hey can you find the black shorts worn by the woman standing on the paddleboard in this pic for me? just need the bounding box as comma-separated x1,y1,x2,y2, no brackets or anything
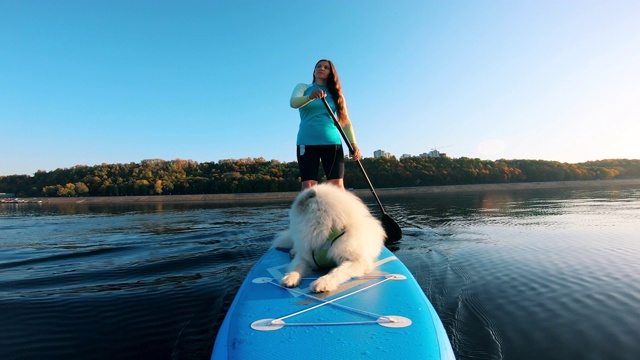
296,145,344,181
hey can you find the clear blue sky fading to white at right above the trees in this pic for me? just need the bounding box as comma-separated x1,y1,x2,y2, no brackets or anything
0,0,640,175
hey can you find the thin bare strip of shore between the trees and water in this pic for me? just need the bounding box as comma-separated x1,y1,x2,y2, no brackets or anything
7,179,640,204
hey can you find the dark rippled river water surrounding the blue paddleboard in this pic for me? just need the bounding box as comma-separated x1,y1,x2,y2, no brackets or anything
0,187,640,360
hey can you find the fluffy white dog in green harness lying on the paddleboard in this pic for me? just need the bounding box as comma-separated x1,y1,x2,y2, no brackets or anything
274,184,386,292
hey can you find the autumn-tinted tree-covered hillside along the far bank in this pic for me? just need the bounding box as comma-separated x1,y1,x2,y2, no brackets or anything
0,157,640,197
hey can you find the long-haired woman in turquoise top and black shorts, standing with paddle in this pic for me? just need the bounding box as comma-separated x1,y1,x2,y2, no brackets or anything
290,59,362,190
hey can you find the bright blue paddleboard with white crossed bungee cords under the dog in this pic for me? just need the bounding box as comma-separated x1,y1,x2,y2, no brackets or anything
211,248,455,360
